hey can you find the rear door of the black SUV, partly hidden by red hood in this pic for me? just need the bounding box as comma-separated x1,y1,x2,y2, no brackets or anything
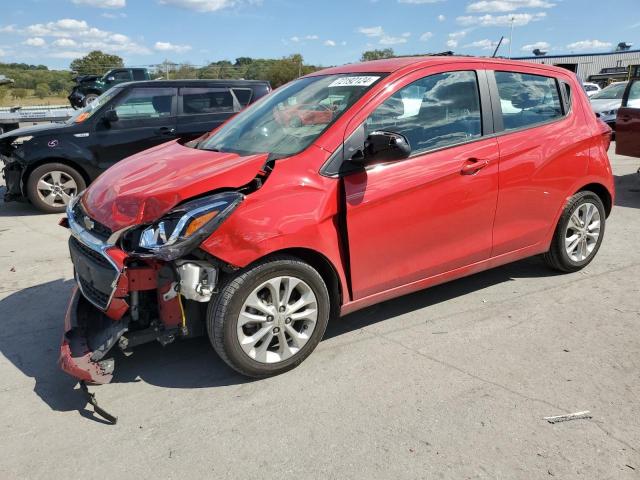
177,87,241,139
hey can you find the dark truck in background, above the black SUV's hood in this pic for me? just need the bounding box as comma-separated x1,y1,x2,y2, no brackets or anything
68,68,151,108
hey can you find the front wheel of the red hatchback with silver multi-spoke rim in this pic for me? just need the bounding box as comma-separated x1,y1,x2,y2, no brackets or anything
207,257,331,378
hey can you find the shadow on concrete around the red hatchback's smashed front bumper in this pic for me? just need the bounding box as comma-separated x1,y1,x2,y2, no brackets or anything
0,280,250,422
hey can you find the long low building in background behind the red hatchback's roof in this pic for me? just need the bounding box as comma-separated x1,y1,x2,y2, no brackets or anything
514,50,640,87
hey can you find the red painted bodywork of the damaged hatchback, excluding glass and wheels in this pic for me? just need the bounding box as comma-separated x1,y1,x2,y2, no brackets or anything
61,57,614,378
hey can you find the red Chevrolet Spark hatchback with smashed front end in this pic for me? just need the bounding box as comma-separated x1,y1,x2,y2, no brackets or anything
60,57,614,383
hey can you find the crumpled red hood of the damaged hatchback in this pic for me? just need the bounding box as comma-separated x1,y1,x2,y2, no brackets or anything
82,141,268,231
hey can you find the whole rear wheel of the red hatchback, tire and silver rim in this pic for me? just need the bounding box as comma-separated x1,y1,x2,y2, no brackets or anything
544,191,606,272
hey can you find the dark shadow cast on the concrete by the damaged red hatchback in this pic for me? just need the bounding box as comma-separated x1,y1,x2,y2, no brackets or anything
0,258,554,422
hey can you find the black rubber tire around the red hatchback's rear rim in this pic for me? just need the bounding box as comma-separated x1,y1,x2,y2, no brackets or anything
543,191,606,272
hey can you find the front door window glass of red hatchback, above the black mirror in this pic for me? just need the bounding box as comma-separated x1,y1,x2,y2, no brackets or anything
365,71,482,154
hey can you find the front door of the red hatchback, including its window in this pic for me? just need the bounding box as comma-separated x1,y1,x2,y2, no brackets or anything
344,70,499,299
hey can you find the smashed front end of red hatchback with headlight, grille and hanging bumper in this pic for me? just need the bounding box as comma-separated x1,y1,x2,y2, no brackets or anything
59,192,238,384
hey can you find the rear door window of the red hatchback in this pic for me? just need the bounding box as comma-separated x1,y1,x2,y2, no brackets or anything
495,72,563,130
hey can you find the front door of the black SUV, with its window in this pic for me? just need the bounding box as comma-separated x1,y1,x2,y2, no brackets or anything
94,87,177,169
